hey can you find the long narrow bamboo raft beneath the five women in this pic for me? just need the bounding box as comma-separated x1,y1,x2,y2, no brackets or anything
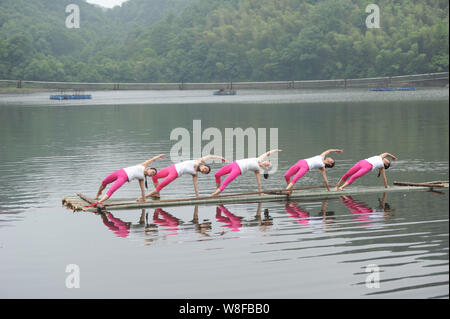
62,181,448,212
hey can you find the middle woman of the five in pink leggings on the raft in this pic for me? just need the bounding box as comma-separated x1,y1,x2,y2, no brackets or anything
211,150,281,196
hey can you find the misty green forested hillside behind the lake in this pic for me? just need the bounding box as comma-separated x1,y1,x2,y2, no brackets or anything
0,0,449,82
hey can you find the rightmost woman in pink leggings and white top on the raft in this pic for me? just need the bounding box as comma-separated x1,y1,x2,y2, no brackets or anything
336,153,397,190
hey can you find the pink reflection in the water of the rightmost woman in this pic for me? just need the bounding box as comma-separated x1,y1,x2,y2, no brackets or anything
340,193,394,221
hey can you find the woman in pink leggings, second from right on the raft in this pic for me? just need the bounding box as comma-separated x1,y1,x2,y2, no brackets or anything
284,149,343,193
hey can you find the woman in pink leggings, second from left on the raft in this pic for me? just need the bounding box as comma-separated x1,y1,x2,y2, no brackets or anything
145,155,226,198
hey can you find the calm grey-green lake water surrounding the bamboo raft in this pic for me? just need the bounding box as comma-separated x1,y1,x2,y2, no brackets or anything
0,89,449,299
